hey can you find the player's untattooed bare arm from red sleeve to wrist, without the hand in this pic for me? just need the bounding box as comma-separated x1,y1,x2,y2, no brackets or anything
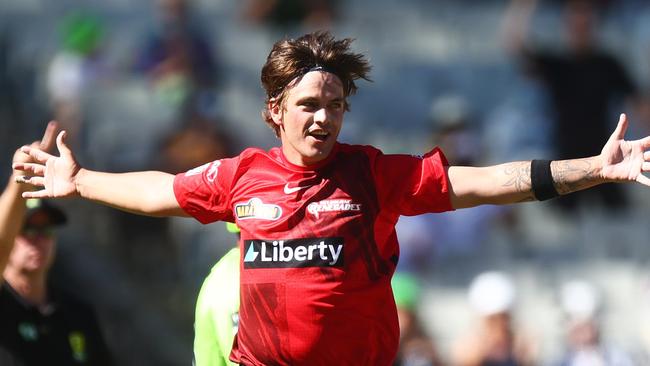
75,169,185,216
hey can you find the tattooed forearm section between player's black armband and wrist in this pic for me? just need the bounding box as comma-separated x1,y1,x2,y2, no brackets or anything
551,158,597,194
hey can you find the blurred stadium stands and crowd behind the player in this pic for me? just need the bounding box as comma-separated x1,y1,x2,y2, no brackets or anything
0,0,650,365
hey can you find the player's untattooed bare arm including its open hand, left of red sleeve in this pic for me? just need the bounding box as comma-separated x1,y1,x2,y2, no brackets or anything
13,127,187,216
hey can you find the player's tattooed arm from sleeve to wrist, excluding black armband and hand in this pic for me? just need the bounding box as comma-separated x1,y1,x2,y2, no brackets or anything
448,157,605,208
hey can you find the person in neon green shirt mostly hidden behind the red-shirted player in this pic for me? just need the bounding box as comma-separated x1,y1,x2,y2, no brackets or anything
194,223,239,366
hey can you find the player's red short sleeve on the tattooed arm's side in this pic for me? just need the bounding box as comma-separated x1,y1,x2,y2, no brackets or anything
374,148,453,216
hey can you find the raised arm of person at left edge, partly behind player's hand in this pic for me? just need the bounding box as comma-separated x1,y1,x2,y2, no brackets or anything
0,122,57,283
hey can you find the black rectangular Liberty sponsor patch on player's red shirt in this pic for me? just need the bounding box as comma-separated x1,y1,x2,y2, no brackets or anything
244,238,344,268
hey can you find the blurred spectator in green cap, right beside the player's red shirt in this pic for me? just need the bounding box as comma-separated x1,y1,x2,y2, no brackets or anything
391,272,442,366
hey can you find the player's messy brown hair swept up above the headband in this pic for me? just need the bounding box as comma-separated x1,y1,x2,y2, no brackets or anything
261,31,371,137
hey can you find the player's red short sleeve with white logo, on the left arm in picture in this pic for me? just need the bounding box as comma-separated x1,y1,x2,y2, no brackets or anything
174,158,239,224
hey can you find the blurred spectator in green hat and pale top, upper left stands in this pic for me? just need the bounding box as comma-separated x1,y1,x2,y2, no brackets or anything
47,12,106,149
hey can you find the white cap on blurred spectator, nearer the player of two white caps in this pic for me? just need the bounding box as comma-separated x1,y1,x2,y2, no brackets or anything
468,271,515,316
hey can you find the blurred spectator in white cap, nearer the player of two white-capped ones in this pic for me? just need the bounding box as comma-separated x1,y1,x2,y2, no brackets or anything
452,272,537,366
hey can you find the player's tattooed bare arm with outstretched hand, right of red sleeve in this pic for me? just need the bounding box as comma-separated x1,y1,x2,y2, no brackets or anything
448,114,650,208
